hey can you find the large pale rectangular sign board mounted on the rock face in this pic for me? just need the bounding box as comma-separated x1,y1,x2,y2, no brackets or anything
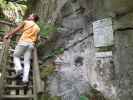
93,18,113,47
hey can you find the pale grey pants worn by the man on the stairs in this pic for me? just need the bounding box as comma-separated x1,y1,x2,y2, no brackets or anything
13,43,34,82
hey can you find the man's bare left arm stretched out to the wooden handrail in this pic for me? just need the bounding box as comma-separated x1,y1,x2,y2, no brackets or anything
4,23,24,39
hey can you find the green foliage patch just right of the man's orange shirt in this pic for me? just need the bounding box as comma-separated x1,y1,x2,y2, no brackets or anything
38,22,57,37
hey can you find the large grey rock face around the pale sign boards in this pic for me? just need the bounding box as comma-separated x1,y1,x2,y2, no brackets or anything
31,0,133,100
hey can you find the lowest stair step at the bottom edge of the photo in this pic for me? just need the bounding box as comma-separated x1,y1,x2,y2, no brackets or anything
2,95,34,100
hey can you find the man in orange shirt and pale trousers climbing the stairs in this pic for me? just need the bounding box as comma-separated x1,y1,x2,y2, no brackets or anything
4,14,40,84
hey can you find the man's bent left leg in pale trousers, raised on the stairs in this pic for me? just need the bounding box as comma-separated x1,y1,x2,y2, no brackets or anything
13,45,26,73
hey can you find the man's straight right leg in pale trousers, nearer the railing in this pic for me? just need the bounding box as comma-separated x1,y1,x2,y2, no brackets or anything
22,47,33,83
